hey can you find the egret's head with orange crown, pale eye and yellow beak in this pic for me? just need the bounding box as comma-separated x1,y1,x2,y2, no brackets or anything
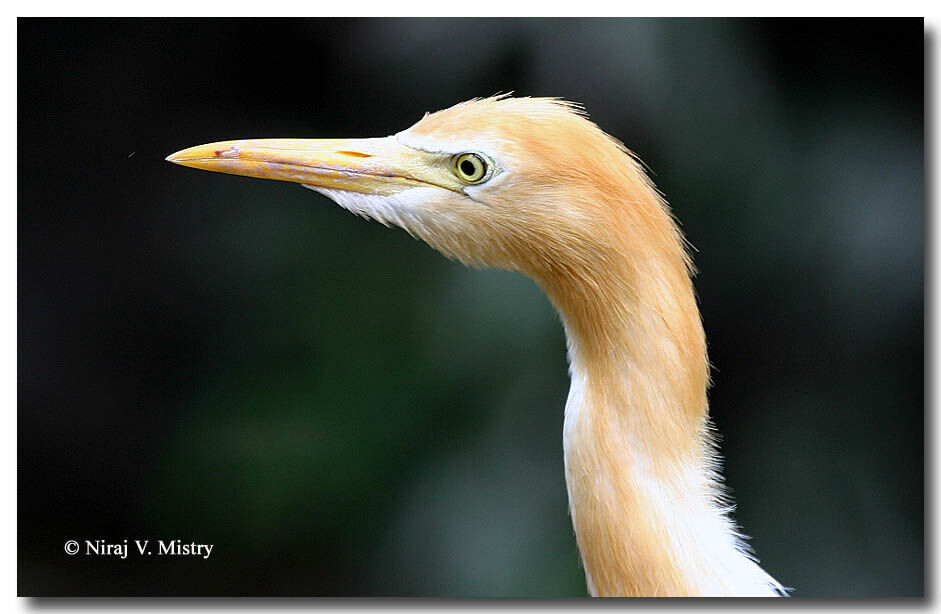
167,96,661,288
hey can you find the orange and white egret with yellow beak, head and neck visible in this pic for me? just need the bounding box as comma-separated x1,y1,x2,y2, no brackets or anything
167,96,785,597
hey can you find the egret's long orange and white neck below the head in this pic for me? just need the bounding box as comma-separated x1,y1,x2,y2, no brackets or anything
539,194,776,596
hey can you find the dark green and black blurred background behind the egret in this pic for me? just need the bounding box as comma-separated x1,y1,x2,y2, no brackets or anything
18,19,925,596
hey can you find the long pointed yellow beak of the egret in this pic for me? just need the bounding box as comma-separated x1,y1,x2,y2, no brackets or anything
167,137,453,196
